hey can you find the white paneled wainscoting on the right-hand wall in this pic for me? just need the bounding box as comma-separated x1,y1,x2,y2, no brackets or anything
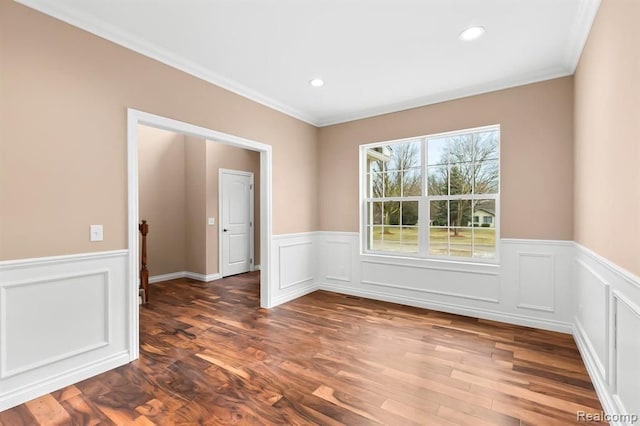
574,244,640,424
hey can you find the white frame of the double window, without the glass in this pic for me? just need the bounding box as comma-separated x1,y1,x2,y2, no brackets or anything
359,124,502,264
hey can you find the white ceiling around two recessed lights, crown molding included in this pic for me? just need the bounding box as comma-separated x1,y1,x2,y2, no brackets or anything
18,0,600,126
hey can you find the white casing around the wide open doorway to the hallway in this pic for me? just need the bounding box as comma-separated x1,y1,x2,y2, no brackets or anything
126,108,273,361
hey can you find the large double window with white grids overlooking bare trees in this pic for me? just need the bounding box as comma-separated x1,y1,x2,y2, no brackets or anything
361,126,500,260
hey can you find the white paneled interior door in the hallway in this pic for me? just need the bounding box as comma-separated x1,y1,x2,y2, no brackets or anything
219,170,253,277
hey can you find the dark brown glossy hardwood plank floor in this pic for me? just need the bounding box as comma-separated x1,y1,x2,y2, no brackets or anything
0,273,602,426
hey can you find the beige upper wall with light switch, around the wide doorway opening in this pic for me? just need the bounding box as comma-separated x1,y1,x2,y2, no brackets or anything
0,1,318,260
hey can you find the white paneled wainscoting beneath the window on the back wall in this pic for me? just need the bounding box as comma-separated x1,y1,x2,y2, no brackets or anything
315,232,574,333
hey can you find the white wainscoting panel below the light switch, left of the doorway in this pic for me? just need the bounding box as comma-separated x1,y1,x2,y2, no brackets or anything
0,250,129,411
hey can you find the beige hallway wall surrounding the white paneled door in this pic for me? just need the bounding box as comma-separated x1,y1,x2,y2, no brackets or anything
207,141,260,274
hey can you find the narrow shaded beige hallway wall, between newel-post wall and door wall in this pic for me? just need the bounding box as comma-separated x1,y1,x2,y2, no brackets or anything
184,136,210,274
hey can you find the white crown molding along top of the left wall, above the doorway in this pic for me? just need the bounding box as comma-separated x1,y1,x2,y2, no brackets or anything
15,0,318,126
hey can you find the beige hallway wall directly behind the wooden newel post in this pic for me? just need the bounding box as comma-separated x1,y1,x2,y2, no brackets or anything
138,126,187,275
